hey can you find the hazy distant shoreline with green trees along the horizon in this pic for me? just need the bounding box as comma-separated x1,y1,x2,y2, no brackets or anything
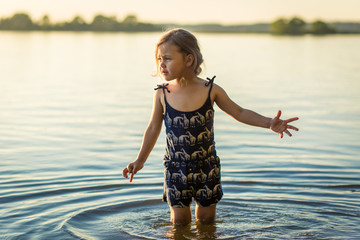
0,13,354,35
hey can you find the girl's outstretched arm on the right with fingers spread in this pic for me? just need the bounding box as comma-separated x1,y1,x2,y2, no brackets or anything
213,84,299,138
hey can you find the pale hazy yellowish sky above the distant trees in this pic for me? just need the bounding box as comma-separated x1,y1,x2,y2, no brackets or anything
0,0,360,24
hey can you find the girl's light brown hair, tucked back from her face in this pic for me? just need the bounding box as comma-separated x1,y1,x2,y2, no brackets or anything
155,28,204,76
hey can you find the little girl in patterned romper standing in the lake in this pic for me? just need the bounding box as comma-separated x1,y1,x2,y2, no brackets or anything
123,29,298,224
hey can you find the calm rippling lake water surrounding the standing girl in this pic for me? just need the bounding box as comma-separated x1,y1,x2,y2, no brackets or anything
0,32,360,239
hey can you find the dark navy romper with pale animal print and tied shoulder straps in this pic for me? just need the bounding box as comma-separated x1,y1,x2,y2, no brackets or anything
156,77,223,207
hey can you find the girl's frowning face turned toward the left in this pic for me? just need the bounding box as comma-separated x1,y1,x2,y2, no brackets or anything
157,43,188,81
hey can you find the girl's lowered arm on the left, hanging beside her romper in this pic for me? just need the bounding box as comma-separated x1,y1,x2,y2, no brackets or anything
123,90,163,178
